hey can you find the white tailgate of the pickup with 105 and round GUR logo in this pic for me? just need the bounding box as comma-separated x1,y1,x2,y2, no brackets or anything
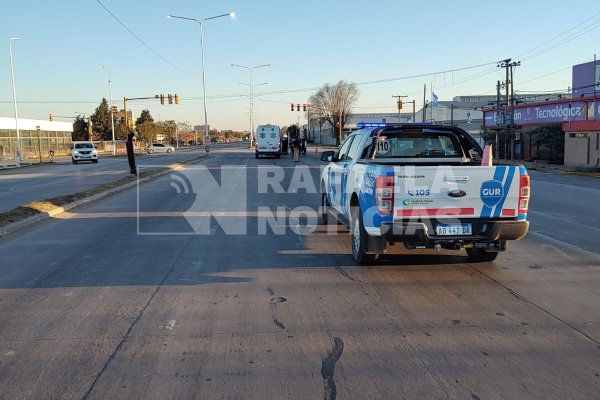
393,166,525,220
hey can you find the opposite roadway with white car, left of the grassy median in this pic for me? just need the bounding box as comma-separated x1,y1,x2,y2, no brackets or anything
0,148,214,212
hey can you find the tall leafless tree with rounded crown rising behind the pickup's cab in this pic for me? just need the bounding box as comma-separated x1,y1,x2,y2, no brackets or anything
309,80,358,144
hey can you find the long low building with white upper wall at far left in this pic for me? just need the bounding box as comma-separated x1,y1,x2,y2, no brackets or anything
0,117,73,158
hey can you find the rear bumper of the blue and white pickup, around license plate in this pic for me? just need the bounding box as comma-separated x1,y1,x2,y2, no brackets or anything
380,220,529,243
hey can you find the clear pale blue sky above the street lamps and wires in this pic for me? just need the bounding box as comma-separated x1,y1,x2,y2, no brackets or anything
0,0,600,130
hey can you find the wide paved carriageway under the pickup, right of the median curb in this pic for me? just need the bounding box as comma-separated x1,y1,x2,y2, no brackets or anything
0,148,600,399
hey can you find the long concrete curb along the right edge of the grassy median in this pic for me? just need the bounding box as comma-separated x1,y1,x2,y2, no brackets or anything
0,155,211,239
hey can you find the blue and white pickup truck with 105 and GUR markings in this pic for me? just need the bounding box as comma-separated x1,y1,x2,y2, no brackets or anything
321,124,530,264
